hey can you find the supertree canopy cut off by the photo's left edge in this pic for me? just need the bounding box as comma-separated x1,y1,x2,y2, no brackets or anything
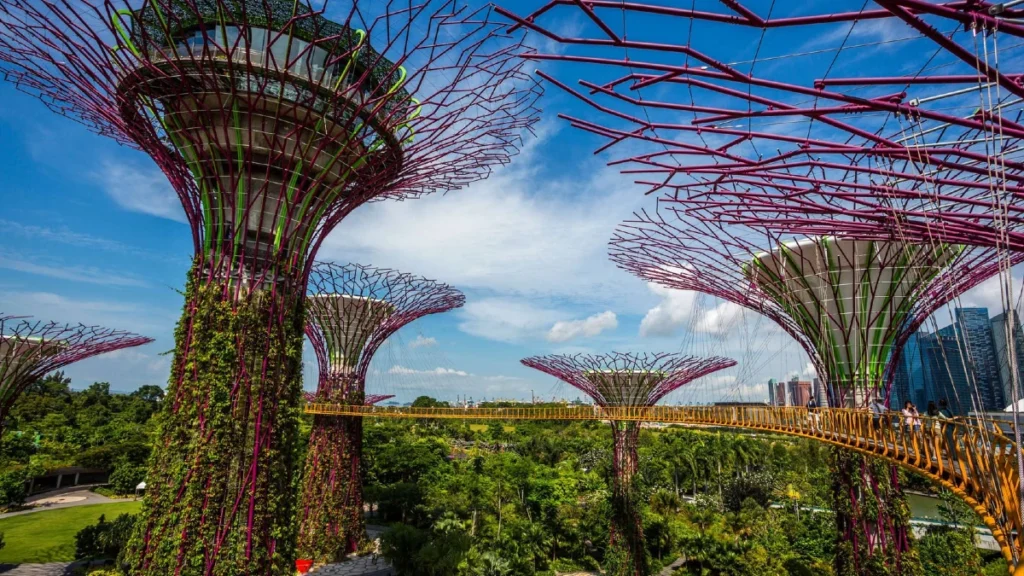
0,314,153,436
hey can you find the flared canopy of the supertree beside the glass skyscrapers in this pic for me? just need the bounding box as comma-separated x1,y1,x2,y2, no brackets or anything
609,200,1024,406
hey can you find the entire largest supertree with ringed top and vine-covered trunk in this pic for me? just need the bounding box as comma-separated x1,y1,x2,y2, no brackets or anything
0,0,540,575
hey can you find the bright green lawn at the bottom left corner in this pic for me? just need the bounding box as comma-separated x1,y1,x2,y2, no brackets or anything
0,501,142,564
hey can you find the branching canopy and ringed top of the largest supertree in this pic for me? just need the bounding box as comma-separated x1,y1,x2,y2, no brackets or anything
0,0,541,286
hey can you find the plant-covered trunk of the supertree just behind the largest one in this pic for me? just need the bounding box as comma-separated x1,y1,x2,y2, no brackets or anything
298,385,366,564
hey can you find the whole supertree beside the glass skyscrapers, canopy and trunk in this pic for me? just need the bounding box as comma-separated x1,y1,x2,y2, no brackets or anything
610,202,1024,574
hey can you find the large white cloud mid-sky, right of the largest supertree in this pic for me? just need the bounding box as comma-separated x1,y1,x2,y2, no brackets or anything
317,126,647,305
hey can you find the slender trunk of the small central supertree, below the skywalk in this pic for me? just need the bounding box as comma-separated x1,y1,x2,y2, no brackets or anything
605,416,648,576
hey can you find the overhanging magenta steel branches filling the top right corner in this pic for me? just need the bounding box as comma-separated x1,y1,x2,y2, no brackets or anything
501,0,1024,250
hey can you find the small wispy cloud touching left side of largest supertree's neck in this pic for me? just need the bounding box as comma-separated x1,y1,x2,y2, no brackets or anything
96,161,186,222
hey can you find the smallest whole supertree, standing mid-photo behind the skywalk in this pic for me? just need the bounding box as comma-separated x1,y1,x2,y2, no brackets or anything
522,353,736,576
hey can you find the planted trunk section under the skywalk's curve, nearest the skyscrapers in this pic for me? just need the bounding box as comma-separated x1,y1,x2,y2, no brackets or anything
829,448,923,576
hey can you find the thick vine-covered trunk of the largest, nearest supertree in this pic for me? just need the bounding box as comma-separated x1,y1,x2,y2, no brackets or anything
126,265,304,576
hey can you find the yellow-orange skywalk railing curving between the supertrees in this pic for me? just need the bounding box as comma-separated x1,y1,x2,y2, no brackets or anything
306,404,1024,565
